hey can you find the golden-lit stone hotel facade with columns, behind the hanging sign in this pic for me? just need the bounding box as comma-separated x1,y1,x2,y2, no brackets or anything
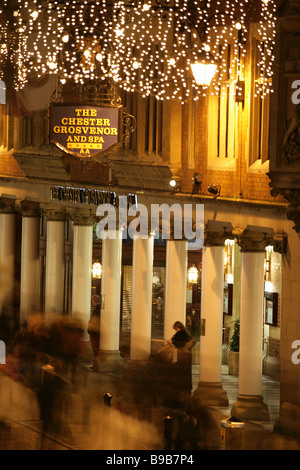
0,1,300,438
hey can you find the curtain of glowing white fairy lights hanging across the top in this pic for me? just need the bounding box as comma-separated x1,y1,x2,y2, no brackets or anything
0,0,275,101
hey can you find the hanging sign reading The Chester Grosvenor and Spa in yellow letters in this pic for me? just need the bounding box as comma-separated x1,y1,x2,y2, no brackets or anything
50,104,120,157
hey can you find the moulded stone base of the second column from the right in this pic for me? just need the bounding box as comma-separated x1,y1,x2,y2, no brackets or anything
193,382,229,406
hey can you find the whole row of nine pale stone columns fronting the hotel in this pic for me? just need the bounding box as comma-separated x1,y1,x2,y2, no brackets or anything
0,197,286,420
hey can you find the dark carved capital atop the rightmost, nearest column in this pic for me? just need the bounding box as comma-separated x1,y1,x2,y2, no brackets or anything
233,227,274,253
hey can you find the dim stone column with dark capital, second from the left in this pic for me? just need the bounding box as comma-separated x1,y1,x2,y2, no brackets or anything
20,200,40,324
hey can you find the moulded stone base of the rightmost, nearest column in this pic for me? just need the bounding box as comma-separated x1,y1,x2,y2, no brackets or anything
231,395,270,421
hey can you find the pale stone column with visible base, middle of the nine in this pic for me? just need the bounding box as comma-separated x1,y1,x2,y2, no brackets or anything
99,230,124,372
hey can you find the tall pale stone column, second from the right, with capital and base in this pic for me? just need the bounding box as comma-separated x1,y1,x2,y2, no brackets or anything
193,232,228,406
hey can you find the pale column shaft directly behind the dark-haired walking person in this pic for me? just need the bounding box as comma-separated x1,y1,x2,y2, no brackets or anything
164,240,188,340
